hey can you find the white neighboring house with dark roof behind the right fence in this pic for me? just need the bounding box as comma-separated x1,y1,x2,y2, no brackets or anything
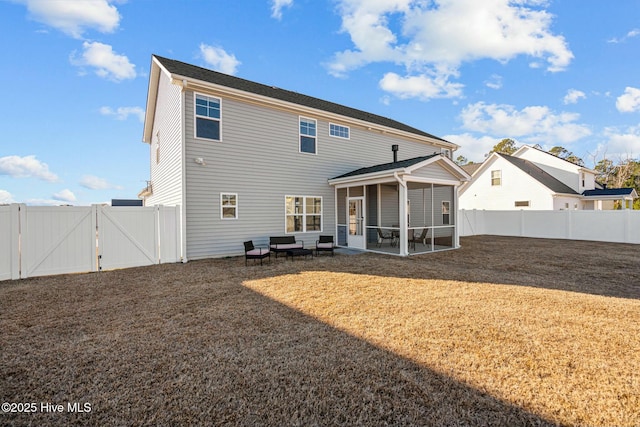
459,145,638,210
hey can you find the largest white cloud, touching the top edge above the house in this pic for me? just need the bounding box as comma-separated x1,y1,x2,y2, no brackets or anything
327,0,573,96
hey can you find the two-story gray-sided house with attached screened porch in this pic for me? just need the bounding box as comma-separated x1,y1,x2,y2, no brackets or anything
139,56,470,261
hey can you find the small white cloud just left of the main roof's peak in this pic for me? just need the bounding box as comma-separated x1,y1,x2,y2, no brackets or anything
70,42,136,82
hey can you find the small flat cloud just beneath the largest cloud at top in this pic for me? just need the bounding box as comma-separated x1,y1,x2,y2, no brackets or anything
380,73,464,100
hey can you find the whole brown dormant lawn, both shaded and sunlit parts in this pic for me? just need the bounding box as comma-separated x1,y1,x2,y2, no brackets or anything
0,236,640,426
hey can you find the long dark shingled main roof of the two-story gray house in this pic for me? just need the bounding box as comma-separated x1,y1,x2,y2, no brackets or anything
153,55,449,142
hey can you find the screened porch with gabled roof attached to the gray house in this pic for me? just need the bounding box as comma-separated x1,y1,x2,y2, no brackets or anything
329,155,468,256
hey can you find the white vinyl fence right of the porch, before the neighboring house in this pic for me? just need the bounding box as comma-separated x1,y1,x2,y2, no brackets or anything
458,209,640,244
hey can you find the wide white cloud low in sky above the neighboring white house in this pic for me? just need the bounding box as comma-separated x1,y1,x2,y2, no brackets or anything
460,102,591,144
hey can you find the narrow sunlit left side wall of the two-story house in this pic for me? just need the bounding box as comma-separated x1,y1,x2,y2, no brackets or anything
145,73,182,206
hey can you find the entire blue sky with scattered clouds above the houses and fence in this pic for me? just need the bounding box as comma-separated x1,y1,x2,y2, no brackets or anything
0,0,640,205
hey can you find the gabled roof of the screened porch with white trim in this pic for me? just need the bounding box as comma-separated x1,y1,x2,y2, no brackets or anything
329,153,471,186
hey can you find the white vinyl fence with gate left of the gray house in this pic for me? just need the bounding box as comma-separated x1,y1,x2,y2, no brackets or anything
0,204,181,280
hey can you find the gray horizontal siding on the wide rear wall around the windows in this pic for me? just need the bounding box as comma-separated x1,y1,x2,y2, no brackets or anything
184,91,439,259
